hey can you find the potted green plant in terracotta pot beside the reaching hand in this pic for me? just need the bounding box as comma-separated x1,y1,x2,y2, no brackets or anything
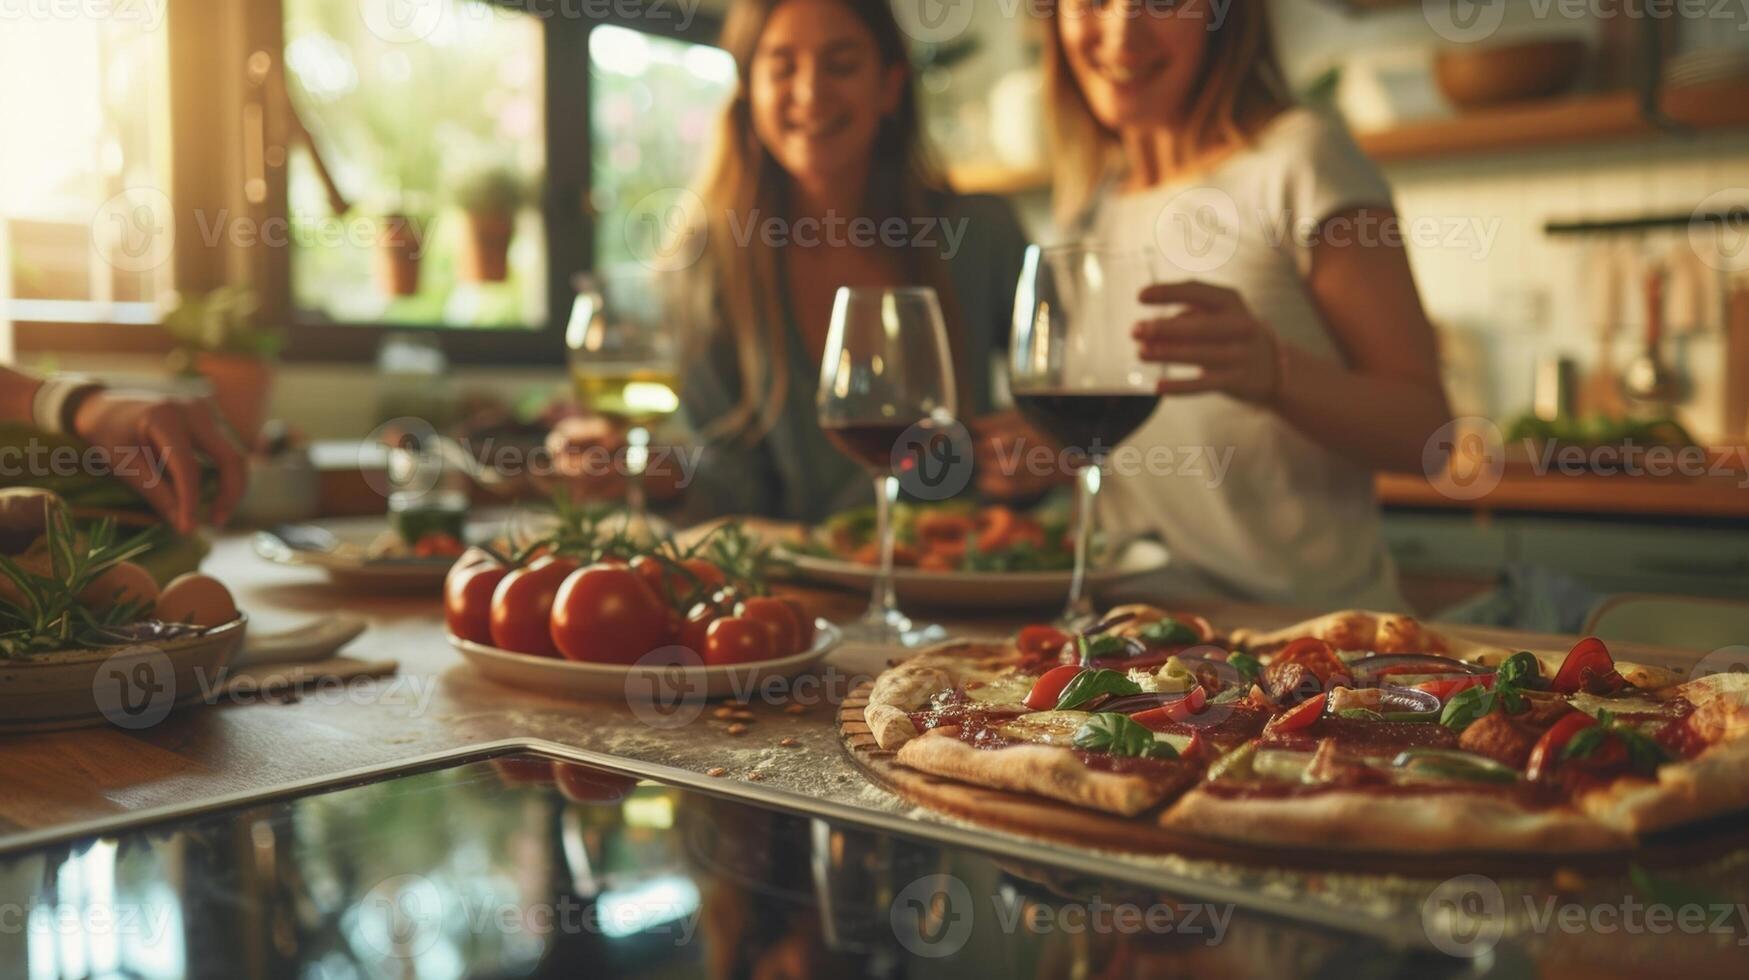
164,285,283,446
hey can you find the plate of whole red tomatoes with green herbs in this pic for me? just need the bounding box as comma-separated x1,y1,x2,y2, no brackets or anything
444,511,838,698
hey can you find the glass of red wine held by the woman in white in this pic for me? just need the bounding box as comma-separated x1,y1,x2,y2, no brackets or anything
1009,245,1163,625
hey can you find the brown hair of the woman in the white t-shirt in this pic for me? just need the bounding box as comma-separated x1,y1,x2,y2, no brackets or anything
1035,0,1293,228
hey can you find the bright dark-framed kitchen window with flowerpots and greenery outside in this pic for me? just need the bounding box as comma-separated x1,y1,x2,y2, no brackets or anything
0,0,735,364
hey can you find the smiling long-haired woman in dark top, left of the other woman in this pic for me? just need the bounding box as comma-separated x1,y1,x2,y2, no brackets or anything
661,0,1027,522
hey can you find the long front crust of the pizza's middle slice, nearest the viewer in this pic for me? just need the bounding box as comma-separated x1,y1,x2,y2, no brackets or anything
1160,789,1632,854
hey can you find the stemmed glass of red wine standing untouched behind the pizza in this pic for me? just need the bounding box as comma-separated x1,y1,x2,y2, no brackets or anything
817,287,958,646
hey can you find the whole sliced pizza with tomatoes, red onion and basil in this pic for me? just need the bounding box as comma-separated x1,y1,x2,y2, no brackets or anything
864,606,1749,852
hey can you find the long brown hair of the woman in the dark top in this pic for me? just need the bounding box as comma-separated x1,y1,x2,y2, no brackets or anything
696,0,951,439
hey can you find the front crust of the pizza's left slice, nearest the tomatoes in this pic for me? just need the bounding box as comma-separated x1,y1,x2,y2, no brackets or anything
899,728,1174,817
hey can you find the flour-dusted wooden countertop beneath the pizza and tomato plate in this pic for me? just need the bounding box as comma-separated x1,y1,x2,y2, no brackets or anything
0,536,1749,975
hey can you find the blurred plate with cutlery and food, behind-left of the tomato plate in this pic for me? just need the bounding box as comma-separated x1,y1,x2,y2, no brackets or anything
254,494,486,592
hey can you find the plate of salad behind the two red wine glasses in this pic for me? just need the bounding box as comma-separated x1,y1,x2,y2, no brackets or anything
778,501,1168,609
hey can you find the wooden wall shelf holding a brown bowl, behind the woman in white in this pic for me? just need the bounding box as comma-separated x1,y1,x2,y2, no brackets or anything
948,79,1749,194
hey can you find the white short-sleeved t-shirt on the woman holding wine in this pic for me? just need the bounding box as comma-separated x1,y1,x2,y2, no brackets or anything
1086,109,1404,609
